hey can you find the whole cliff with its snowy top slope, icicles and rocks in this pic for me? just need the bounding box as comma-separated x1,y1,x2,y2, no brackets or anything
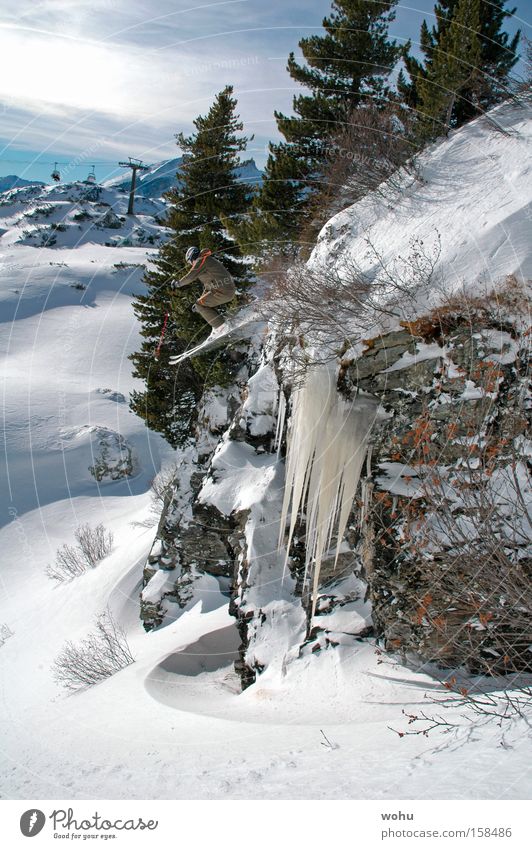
143,97,532,685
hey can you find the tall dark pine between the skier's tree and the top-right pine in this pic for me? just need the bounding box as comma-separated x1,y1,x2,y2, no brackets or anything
233,0,400,250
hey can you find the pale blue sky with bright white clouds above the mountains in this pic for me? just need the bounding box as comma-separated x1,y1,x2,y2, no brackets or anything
0,0,532,181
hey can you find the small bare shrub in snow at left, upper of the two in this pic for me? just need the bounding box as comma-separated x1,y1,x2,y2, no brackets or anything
45,523,113,583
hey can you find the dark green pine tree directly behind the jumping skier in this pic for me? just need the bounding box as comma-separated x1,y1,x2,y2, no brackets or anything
131,86,251,446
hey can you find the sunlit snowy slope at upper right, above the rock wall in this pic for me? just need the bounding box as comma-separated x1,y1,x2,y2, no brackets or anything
311,101,532,326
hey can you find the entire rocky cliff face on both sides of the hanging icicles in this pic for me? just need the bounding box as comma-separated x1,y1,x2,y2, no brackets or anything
141,288,532,687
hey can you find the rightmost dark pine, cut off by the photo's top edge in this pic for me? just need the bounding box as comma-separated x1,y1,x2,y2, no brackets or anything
398,0,520,126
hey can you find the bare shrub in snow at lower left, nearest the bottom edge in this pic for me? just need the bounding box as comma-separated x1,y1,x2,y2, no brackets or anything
52,608,135,691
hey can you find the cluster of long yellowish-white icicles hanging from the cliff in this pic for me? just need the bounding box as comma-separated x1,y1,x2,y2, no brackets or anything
277,366,377,616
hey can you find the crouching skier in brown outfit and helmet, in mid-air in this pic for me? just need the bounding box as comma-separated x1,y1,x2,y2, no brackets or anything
173,247,236,332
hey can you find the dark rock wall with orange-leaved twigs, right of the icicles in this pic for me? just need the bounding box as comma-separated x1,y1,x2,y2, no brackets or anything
342,300,532,674
